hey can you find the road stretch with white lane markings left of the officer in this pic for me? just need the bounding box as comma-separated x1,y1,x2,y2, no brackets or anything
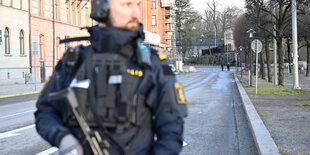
0,98,56,155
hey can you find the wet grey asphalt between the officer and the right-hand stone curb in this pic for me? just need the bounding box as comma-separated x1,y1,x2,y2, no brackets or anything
178,67,257,155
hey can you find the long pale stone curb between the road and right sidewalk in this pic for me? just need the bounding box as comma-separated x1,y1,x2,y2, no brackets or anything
234,74,280,155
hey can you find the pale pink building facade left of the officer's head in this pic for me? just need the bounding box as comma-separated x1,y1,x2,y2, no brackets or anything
30,0,93,82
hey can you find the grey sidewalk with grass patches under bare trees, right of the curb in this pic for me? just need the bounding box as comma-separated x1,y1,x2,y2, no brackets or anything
235,72,310,155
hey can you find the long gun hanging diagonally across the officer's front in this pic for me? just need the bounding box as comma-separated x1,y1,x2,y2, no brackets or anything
48,88,109,155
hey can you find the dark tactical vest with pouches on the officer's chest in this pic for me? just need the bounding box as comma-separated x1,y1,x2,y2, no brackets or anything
63,43,154,136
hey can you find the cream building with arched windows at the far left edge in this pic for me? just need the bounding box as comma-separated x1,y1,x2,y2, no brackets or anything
0,0,30,85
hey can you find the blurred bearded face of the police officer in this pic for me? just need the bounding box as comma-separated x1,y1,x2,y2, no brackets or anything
109,0,141,31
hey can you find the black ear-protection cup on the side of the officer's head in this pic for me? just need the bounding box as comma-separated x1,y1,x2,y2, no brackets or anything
90,0,109,22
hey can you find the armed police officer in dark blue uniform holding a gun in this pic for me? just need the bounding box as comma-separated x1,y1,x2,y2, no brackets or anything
35,0,187,155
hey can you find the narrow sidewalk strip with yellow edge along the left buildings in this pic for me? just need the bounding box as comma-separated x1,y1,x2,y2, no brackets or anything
0,83,45,98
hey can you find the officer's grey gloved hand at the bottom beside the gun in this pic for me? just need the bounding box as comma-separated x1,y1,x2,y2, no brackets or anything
59,134,83,155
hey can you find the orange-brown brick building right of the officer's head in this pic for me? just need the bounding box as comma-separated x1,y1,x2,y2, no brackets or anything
140,0,175,55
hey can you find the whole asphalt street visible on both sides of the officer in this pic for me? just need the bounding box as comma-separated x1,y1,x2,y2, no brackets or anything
0,67,257,155
